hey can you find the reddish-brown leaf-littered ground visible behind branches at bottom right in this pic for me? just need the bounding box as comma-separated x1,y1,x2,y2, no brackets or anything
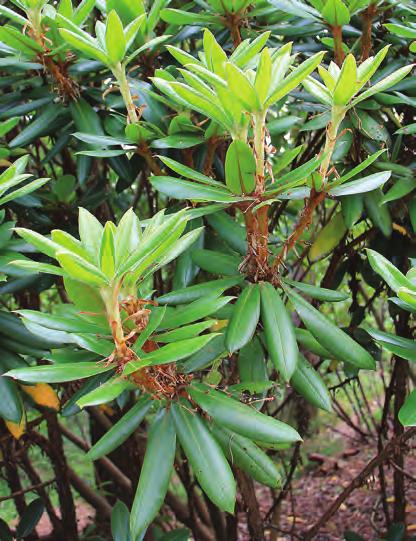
239,425,416,541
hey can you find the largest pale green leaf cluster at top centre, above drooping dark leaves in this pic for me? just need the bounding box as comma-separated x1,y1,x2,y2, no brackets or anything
153,30,323,140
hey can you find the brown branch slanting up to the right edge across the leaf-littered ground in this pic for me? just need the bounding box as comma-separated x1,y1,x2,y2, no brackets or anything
303,427,416,541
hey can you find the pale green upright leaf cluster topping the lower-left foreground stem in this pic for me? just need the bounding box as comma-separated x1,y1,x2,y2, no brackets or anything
11,208,197,292
